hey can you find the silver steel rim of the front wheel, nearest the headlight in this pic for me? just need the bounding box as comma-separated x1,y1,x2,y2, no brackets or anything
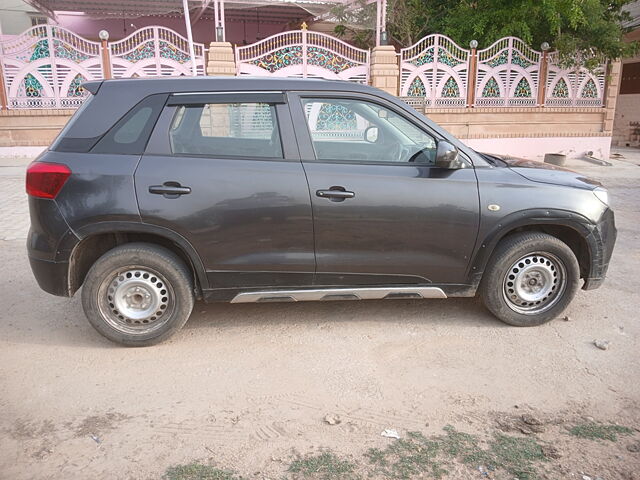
502,252,567,315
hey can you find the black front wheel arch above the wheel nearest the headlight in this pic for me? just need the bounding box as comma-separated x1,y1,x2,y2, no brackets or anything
468,209,595,286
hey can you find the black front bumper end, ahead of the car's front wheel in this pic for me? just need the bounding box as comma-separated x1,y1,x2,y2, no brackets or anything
582,209,618,290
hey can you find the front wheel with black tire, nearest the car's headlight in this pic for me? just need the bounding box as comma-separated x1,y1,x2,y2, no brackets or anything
480,232,580,327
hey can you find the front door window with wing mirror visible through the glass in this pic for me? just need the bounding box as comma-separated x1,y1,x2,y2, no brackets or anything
303,98,436,164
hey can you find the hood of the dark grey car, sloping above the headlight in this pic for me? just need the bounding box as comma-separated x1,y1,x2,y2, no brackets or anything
491,155,602,190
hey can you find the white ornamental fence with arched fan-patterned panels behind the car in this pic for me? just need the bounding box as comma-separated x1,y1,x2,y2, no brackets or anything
0,25,606,109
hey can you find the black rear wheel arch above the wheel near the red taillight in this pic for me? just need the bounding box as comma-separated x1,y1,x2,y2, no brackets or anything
68,222,209,298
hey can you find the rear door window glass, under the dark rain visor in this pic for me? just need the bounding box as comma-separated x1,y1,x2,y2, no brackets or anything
169,103,282,158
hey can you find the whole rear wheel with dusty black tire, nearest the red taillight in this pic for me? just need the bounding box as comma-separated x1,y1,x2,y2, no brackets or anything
82,243,194,347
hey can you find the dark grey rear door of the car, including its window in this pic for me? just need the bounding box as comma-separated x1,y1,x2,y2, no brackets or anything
135,92,315,288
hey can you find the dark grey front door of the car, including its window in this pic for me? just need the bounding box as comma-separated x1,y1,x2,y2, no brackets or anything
292,94,479,285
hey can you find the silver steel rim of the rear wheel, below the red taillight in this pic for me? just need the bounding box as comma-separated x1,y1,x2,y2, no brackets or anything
98,266,175,335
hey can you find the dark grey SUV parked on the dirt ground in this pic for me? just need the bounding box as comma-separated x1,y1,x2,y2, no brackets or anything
26,77,616,346
